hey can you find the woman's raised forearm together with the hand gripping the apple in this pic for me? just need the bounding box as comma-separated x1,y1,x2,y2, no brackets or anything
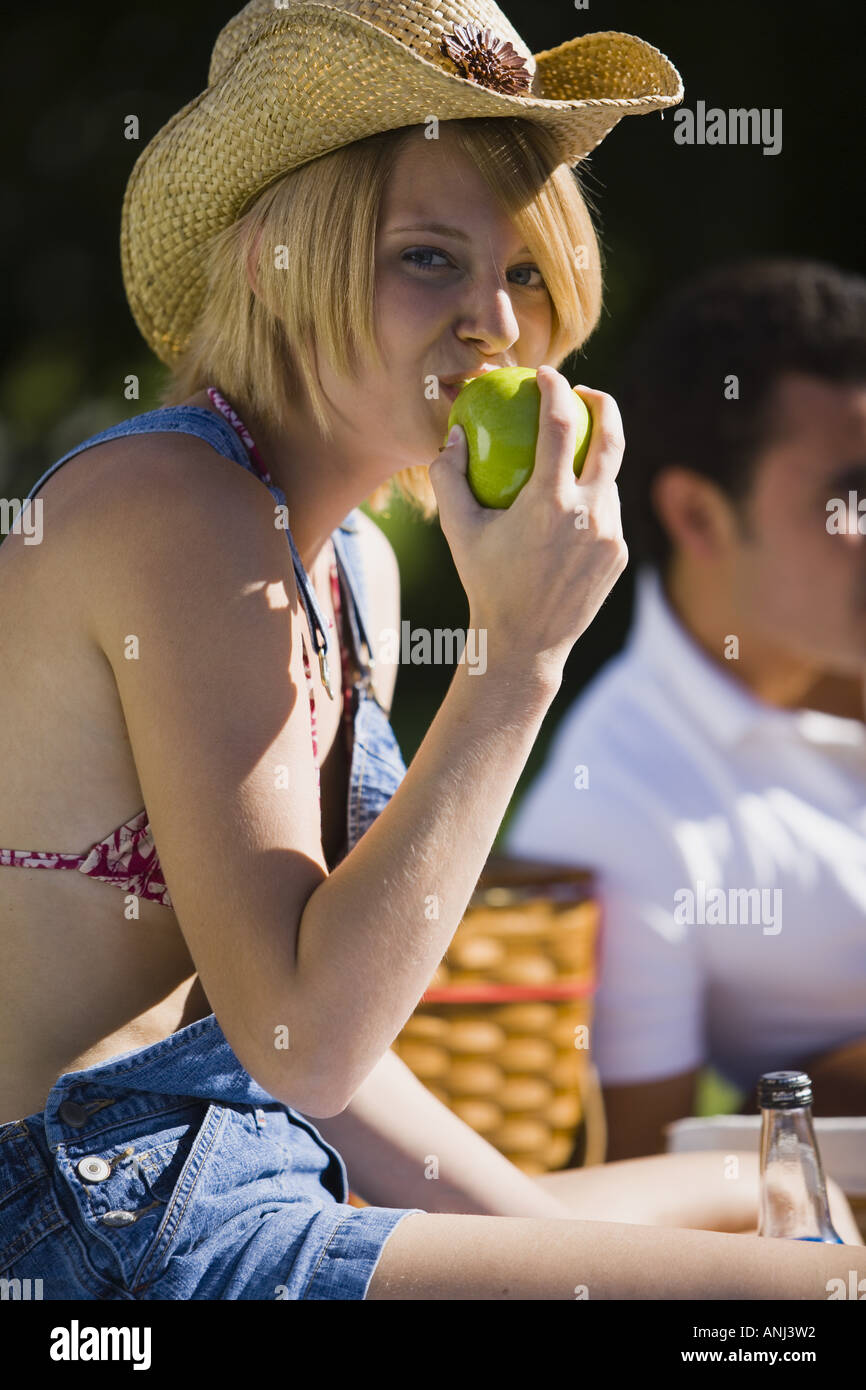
296,371,627,1115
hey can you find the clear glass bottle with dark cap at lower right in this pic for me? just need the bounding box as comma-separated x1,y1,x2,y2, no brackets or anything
758,1072,844,1245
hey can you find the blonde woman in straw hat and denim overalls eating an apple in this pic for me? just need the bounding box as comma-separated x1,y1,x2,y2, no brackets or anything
0,0,866,1300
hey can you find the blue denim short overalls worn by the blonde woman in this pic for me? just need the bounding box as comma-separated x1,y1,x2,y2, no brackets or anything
0,406,421,1300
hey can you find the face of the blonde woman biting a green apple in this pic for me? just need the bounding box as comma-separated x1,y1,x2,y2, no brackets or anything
322,128,552,467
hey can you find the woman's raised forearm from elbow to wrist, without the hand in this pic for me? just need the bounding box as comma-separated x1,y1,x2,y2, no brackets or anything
293,647,557,1097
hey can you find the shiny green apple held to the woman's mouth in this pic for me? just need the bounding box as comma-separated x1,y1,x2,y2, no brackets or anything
448,367,592,507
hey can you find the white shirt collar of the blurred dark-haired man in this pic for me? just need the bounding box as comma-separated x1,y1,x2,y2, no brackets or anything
628,567,866,748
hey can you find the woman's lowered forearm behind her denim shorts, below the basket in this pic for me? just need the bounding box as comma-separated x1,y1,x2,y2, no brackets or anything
316,1049,569,1216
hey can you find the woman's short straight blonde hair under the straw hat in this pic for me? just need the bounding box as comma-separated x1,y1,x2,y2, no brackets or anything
161,117,602,520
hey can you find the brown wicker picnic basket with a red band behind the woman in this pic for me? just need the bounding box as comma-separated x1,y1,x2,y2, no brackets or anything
393,856,606,1175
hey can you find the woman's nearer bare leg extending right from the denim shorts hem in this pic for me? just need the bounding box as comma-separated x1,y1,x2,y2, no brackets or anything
367,1212,866,1300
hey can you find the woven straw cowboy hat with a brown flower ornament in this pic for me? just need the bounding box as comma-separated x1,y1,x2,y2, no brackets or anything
121,0,683,364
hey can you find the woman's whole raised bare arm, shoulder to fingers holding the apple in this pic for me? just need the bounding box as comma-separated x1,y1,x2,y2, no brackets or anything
88,375,626,1118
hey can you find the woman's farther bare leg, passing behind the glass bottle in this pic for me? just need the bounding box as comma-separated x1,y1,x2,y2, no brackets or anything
535,1150,863,1245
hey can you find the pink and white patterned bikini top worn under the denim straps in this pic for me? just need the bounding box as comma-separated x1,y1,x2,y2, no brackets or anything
0,386,352,908
